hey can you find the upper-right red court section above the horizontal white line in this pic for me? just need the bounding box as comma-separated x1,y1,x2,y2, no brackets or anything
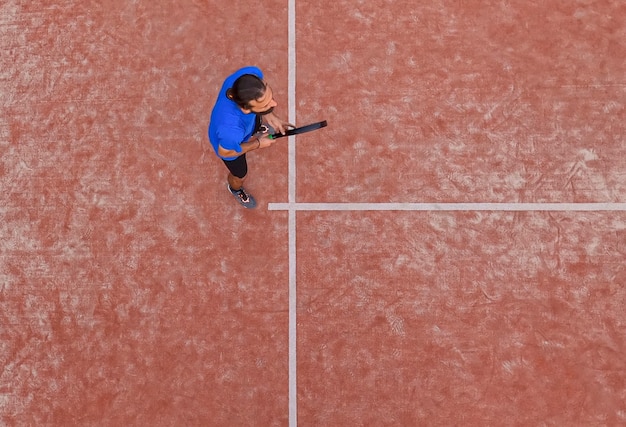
298,0,626,206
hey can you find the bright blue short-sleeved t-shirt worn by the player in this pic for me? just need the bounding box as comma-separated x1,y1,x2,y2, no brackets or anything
209,67,263,160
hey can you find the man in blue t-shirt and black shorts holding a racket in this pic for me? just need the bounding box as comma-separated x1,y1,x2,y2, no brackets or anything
209,67,293,208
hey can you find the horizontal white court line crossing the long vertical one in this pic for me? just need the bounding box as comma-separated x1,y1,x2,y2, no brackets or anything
267,203,626,212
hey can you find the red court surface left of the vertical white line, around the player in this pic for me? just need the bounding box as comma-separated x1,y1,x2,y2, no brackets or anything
0,0,288,426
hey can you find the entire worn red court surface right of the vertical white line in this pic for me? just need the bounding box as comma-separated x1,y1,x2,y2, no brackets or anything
292,0,626,425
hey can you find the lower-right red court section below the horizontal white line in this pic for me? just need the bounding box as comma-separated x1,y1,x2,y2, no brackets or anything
298,212,626,426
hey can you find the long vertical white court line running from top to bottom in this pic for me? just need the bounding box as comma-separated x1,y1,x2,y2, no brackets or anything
287,0,298,427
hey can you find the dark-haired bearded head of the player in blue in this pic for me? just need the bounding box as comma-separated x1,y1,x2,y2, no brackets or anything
226,74,277,114
